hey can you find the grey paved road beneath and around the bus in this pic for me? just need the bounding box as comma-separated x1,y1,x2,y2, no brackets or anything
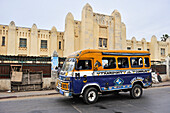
0,87,170,113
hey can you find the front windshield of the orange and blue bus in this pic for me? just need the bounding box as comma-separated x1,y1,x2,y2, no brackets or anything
62,58,76,72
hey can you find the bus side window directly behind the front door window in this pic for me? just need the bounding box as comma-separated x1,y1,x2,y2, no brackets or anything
102,58,116,69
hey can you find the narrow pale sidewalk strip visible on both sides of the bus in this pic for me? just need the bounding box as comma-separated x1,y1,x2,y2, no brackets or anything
0,81,170,100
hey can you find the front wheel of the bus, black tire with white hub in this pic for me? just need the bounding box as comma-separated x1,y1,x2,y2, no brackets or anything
83,87,98,104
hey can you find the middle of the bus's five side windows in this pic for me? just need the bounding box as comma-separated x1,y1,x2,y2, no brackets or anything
118,58,129,68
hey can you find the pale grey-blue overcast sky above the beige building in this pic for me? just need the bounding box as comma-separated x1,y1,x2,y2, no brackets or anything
0,0,170,41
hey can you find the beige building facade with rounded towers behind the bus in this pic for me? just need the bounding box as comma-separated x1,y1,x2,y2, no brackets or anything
0,4,170,61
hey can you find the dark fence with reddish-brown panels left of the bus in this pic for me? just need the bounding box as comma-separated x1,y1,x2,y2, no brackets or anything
0,55,51,79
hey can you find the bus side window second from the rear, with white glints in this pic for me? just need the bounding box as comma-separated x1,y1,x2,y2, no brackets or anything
130,57,143,68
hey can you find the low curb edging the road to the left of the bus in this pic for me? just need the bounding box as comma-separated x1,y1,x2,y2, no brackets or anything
0,93,59,100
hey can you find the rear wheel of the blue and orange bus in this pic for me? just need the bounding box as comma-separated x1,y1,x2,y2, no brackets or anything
130,84,143,99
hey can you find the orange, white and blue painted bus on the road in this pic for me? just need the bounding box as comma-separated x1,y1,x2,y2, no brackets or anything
56,49,152,104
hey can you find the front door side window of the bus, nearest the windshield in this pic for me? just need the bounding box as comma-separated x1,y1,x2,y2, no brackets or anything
77,60,92,70
